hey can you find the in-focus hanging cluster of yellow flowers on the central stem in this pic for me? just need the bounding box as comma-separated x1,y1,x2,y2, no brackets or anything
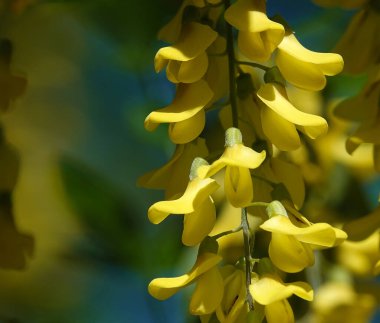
139,0,358,323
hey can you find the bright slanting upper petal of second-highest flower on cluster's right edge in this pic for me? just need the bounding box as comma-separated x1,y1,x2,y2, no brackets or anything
257,83,327,139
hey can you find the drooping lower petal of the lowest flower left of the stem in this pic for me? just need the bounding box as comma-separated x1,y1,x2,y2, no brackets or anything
189,267,224,315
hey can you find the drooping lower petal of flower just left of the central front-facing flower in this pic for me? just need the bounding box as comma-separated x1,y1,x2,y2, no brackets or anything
182,197,216,246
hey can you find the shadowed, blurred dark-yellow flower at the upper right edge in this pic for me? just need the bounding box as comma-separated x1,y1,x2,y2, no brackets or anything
335,5,380,74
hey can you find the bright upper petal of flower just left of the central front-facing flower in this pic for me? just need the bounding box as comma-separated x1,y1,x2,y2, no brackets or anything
148,178,219,224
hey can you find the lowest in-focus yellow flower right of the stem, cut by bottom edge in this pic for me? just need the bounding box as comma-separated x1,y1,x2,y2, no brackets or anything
249,273,313,323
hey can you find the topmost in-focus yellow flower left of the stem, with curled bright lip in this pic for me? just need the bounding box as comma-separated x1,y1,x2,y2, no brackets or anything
154,22,218,83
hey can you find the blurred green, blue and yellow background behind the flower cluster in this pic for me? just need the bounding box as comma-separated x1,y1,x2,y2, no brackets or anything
0,0,379,323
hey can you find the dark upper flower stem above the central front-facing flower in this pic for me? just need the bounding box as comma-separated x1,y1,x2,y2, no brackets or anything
224,0,238,128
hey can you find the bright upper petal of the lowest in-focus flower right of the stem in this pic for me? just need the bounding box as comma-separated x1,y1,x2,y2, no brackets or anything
249,274,313,305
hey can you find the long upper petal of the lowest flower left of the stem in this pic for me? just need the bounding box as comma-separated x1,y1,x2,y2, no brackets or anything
148,253,222,300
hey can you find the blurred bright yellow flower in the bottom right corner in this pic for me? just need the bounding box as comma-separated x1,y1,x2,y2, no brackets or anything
312,282,376,323
